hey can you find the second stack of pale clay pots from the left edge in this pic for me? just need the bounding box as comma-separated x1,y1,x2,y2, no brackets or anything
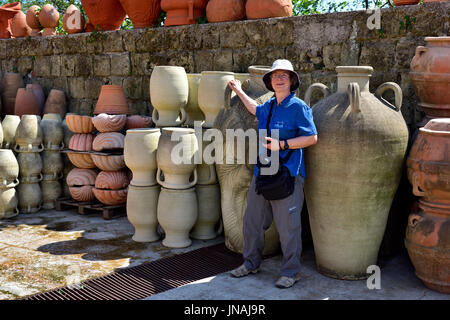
14,114,44,213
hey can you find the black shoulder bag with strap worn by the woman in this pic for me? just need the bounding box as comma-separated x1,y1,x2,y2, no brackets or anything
255,102,295,200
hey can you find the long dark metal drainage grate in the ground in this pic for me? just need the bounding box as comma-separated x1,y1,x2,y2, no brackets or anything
22,243,243,300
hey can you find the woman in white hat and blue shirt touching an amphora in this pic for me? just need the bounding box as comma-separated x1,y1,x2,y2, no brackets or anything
228,59,317,288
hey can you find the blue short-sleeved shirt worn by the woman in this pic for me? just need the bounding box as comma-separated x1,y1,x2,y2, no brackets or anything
254,93,317,178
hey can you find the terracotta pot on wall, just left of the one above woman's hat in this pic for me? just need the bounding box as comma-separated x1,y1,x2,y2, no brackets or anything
206,0,245,22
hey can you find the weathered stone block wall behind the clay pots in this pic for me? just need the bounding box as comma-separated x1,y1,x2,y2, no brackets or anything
0,2,450,125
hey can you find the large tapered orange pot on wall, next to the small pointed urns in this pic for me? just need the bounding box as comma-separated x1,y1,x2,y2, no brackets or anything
81,0,126,31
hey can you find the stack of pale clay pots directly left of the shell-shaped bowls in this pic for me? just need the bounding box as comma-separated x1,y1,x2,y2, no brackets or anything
41,113,64,209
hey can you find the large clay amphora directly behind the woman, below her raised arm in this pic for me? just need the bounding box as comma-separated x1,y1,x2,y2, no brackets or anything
213,66,280,255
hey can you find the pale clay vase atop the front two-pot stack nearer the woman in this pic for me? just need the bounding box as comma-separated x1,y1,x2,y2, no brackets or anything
156,128,198,189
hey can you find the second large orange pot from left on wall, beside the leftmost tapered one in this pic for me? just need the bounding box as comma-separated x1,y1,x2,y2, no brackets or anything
120,0,161,29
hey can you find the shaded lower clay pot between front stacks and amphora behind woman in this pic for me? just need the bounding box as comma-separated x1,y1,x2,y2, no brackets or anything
191,183,222,240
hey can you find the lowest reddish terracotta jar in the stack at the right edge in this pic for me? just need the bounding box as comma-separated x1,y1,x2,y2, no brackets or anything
405,200,450,294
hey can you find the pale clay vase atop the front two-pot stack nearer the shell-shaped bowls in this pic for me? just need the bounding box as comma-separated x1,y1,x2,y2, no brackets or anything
123,128,161,187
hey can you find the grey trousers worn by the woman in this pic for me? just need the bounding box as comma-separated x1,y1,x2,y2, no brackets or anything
243,175,304,277
